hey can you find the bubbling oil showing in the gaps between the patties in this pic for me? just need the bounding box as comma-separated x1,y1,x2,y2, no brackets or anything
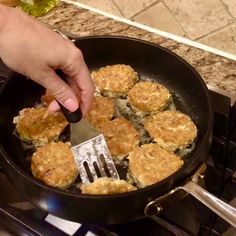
12,78,195,193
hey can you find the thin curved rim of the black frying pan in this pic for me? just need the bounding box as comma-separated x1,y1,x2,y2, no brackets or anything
0,35,213,200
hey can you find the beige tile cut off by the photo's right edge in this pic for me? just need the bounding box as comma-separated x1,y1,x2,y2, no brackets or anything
199,23,236,55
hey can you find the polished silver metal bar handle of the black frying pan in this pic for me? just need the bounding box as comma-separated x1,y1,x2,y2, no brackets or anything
180,181,236,227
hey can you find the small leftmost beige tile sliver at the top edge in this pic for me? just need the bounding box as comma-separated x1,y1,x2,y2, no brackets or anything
75,0,122,16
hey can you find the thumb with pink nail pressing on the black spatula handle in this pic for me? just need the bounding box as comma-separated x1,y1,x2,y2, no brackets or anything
40,70,79,112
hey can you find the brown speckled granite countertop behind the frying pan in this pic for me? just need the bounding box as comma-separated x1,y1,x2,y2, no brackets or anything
38,2,236,95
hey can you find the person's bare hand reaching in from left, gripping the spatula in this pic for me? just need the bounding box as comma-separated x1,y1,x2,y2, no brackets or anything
0,5,94,114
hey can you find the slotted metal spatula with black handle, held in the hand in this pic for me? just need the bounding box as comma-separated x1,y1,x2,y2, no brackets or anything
56,70,119,184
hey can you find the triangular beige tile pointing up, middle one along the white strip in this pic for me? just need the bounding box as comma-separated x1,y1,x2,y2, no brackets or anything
133,3,185,36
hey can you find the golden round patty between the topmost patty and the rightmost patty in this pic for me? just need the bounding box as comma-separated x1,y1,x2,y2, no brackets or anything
128,81,171,117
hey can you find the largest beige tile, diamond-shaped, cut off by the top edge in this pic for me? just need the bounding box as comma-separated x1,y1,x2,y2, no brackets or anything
164,0,232,39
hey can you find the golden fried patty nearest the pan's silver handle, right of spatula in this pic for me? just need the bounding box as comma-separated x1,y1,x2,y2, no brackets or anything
128,143,184,187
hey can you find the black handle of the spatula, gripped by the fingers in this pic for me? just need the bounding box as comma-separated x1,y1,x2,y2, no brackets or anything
56,70,83,123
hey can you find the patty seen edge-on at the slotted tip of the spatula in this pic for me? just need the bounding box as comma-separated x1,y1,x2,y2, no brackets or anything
80,177,137,194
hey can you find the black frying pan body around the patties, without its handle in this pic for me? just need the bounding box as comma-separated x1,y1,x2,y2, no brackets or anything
0,37,234,224
